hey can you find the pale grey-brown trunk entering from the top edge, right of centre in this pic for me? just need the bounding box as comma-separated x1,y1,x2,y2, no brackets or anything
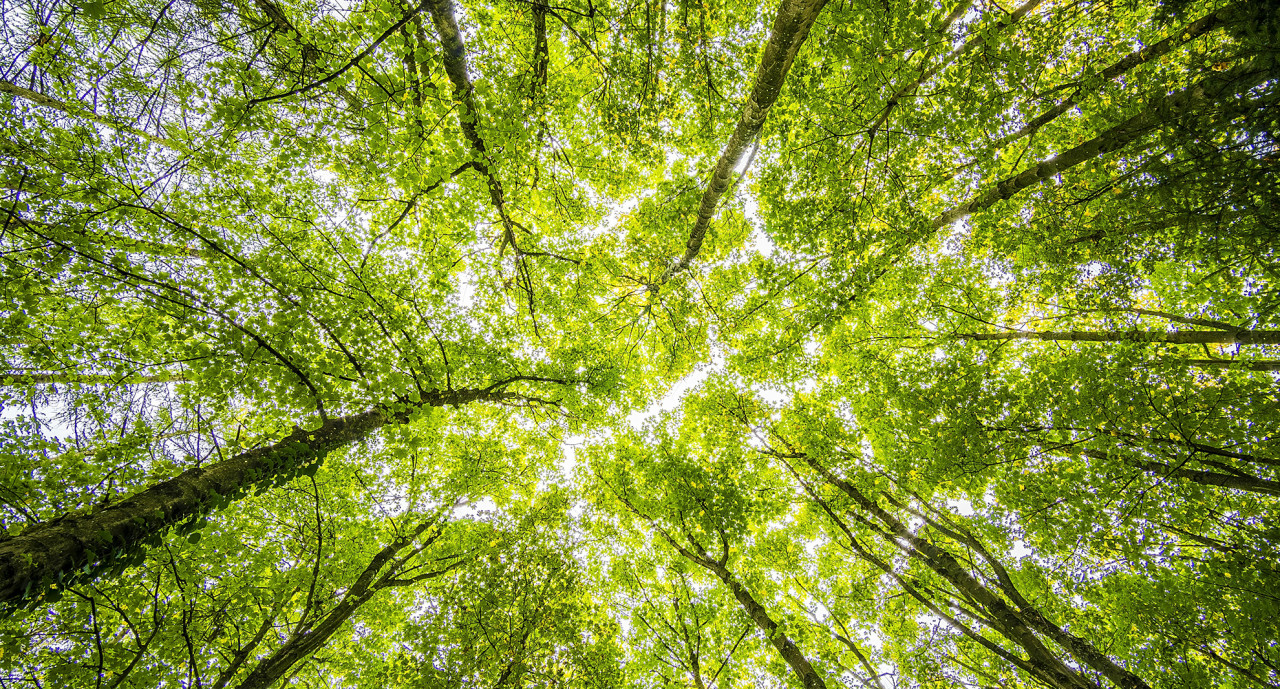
652,0,827,284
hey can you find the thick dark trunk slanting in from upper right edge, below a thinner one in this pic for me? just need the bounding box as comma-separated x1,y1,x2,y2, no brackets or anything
929,63,1272,229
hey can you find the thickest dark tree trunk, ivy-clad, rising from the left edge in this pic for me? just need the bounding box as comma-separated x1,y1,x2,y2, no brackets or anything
0,387,512,606
